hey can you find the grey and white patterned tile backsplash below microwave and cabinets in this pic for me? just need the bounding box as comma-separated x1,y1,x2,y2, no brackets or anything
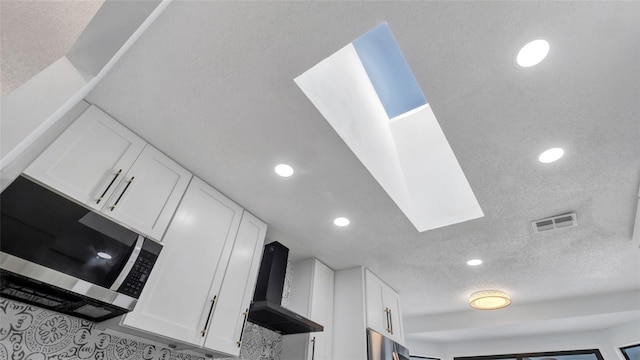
0,299,282,360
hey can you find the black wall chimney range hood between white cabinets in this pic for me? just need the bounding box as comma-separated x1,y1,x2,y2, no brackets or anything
248,242,324,335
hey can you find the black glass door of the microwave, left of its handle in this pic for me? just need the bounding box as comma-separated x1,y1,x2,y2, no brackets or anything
0,176,139,289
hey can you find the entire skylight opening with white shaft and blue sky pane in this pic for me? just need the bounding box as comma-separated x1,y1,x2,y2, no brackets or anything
295,22,484,232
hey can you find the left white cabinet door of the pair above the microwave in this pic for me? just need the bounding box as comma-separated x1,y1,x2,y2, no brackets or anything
24,105,146,210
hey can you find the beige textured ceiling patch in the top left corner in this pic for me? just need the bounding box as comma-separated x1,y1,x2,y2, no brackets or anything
0,0,104,96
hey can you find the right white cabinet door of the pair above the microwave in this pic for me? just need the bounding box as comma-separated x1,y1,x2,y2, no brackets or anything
103,145,191,241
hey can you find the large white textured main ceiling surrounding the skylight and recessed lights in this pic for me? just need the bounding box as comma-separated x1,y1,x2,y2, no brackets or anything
87,2,640,336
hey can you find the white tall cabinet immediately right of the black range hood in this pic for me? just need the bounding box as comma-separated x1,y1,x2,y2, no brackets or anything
281,258,334,360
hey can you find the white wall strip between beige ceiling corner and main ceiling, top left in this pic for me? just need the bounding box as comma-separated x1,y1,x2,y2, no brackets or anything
0,0,169,186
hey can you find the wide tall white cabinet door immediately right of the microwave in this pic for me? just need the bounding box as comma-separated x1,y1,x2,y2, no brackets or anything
122,177,242,346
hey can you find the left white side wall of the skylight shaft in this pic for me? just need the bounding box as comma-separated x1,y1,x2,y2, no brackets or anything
295,44,410,214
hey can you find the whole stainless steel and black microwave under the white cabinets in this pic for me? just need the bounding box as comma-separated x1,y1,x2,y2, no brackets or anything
0,176,162,322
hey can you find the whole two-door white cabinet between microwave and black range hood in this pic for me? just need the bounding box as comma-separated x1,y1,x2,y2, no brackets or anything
114,177,266,356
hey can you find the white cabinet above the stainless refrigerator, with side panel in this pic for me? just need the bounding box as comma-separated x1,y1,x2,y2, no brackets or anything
332,267,404,360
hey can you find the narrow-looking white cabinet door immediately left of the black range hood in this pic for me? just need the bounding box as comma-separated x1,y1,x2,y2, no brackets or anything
204,211,267,356
